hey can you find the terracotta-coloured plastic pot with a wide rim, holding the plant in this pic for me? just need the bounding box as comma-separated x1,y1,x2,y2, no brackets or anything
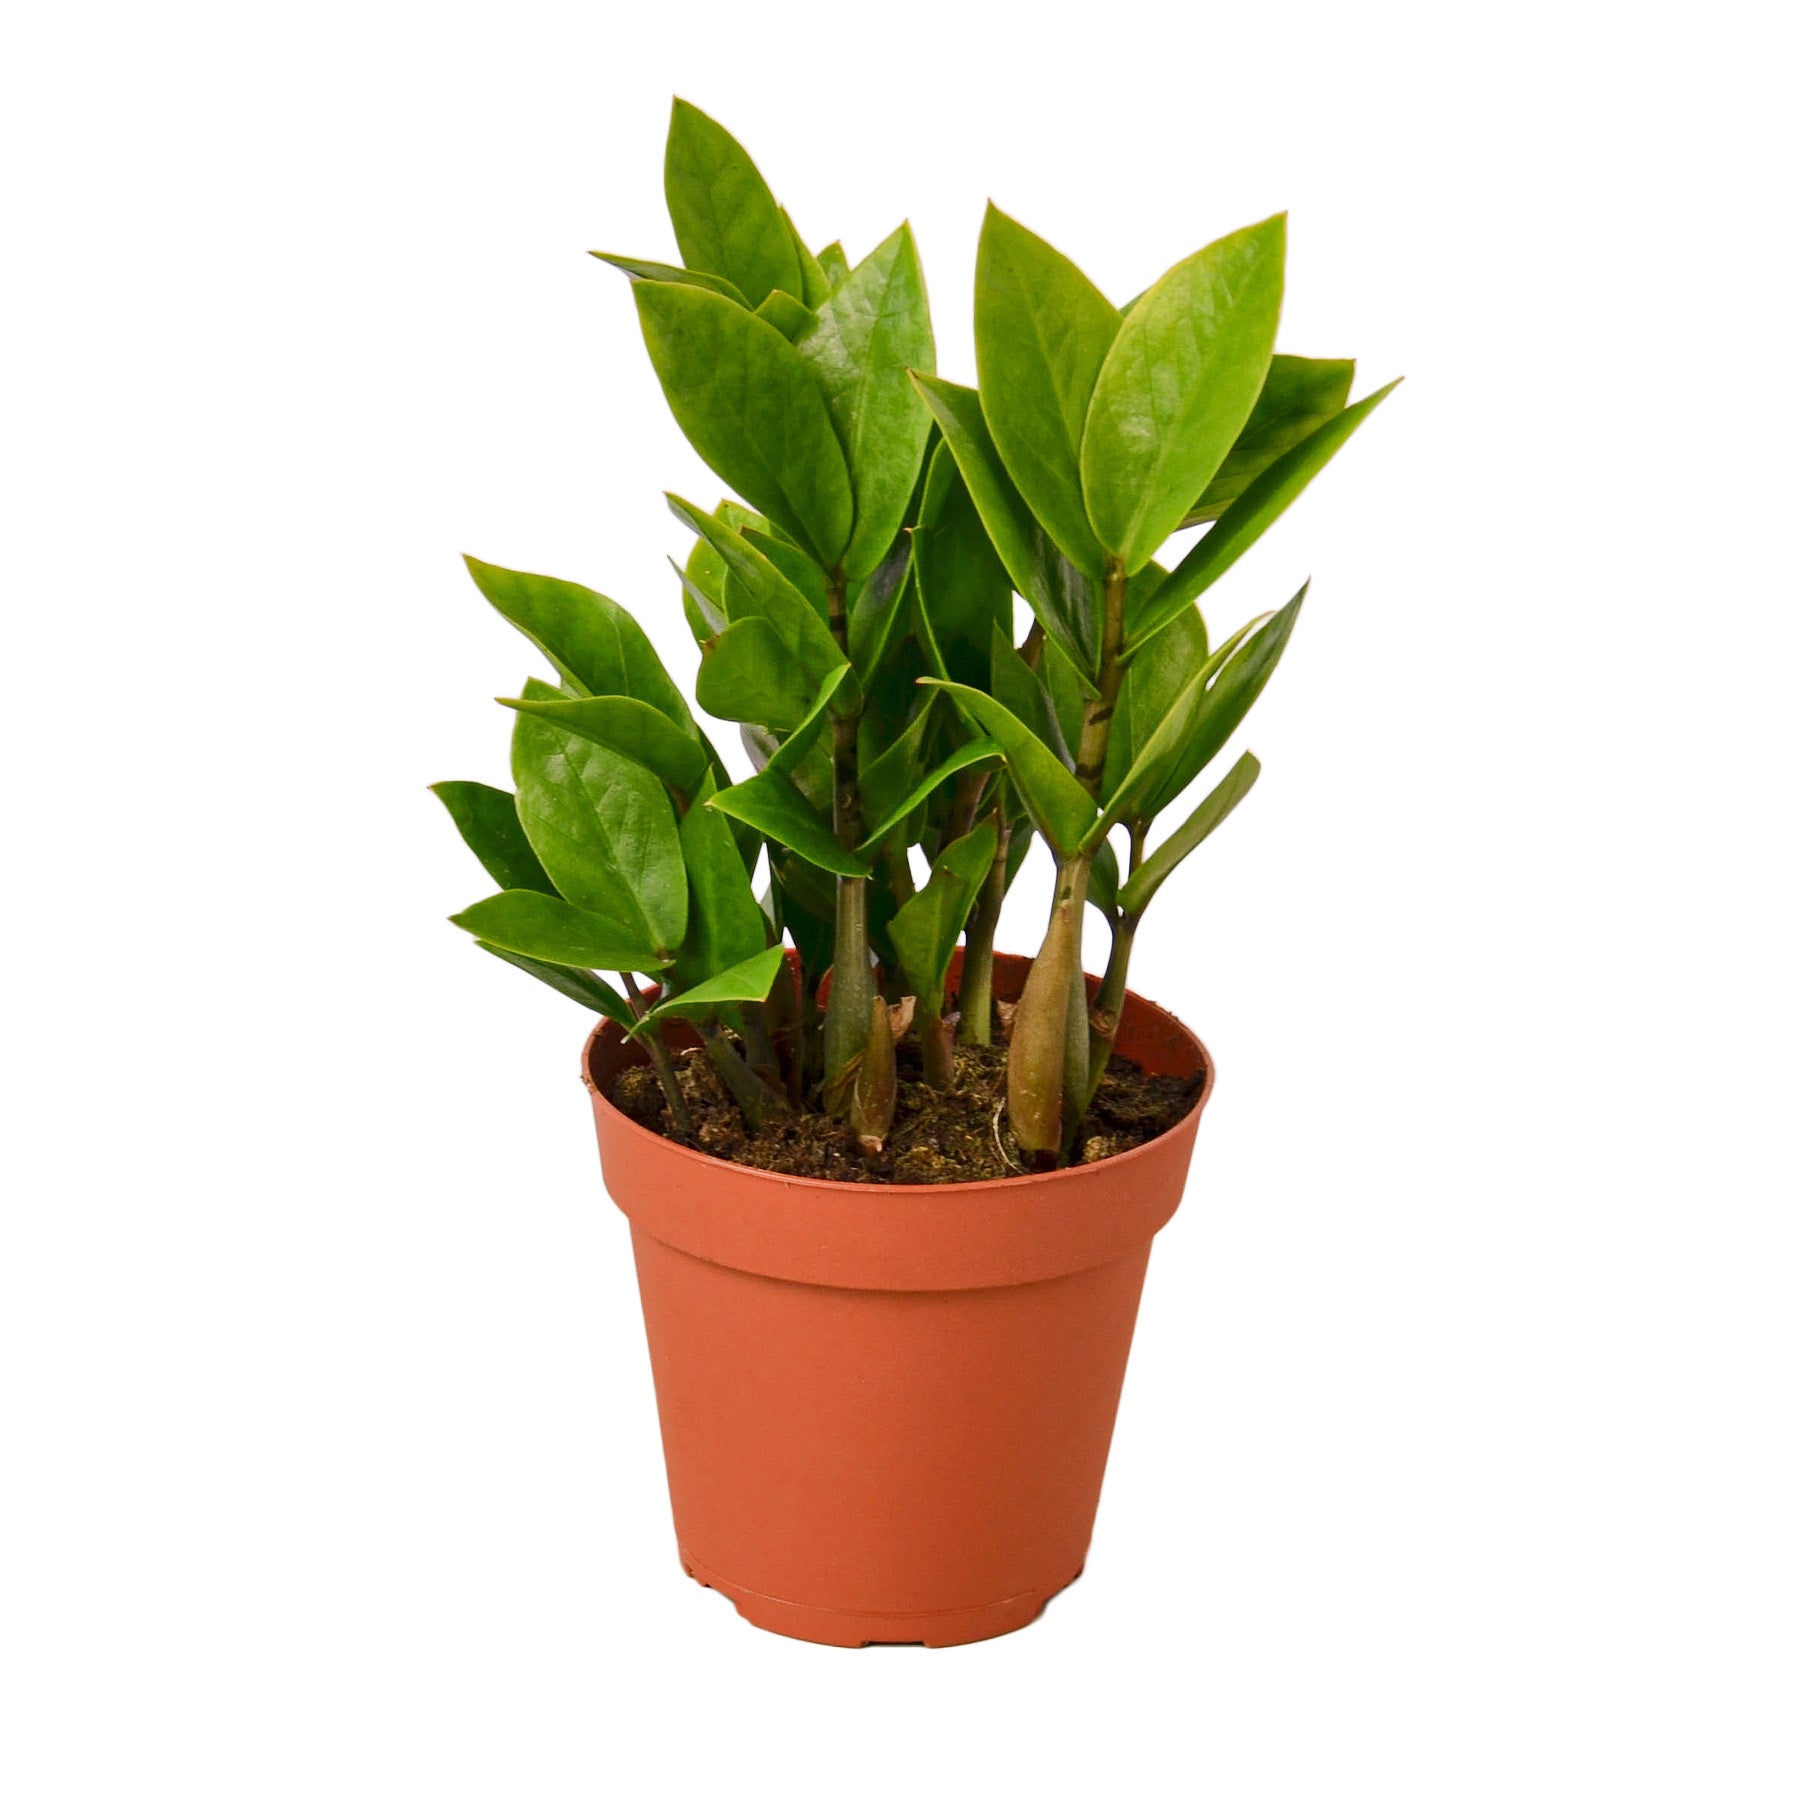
581,956,1213,1645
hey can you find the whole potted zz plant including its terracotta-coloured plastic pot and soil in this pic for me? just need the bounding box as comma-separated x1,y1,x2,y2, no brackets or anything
436,103,1388,1643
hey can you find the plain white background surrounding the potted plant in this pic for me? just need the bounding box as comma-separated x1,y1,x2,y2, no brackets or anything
0,0,1800,1800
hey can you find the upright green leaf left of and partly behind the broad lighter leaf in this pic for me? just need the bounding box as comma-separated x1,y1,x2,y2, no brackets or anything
976,202,1120,580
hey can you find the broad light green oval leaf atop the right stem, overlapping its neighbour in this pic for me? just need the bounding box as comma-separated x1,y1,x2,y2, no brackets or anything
1072,214,1287,569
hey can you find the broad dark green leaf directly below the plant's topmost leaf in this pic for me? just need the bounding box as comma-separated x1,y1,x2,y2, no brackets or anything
632,281,853,569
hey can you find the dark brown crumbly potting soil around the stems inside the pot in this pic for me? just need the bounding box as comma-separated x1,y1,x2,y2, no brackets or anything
612,1042,1202,1183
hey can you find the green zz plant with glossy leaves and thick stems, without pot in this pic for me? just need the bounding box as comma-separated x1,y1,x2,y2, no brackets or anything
434,101,1391,1168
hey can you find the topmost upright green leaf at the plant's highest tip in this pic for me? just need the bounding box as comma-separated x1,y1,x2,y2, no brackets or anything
662,101,805,309
